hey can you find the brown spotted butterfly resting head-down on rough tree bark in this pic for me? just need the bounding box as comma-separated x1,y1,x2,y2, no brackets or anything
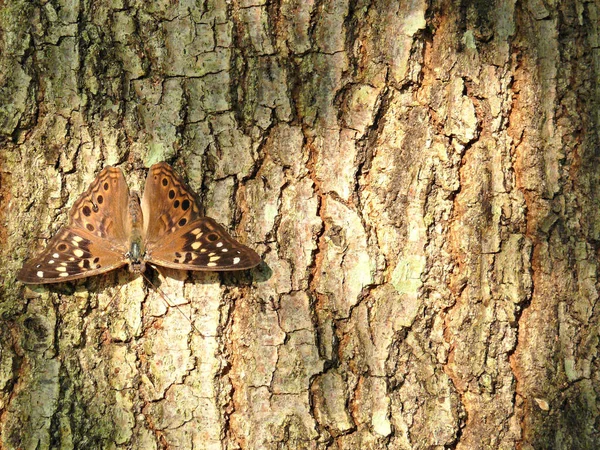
17,162,261,284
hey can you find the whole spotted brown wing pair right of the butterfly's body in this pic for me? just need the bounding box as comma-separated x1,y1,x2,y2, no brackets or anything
142,163,261,270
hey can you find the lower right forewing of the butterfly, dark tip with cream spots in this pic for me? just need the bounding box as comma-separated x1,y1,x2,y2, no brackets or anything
147,217,261,270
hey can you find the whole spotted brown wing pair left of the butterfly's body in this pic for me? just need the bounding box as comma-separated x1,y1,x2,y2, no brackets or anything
17,167,129,284
